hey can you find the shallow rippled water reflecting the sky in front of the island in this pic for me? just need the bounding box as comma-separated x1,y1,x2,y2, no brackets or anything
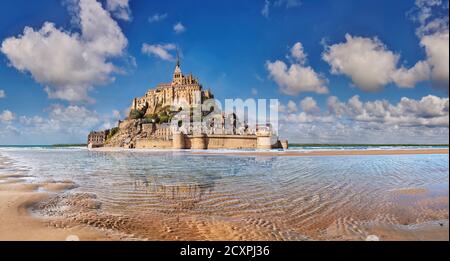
0,148,449,239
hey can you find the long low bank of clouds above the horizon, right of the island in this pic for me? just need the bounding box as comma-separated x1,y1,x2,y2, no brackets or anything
279,95,449,144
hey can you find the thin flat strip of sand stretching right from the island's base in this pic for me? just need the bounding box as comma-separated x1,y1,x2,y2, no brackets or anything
192,149,449,157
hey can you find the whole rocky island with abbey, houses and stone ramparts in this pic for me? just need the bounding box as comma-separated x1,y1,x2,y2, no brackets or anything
88,60,288,149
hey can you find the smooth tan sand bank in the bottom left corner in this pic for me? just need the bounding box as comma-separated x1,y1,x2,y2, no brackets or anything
0,157,116,241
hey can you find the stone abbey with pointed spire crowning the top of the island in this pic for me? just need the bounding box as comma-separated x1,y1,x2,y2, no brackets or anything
130,59,214,115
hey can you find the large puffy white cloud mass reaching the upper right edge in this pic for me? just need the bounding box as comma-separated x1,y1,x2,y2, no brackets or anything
322,0,449,92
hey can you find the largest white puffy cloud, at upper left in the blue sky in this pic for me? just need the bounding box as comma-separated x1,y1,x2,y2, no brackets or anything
0,0,128,102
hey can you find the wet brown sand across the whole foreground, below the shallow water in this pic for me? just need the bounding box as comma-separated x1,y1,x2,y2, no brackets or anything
0,150,449,241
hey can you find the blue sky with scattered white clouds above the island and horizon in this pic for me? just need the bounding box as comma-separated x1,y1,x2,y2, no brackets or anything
0,0,448,144
